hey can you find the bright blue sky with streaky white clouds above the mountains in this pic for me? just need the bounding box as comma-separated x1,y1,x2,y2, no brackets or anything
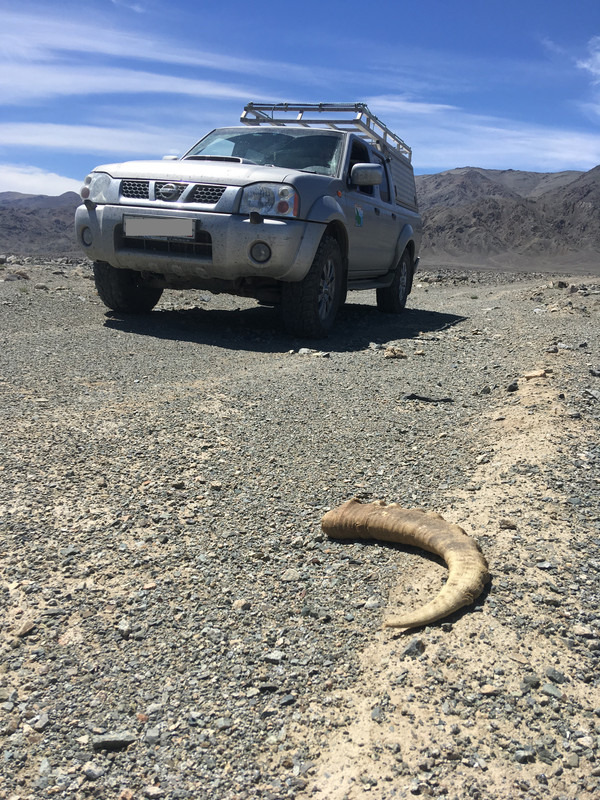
0,0,600,194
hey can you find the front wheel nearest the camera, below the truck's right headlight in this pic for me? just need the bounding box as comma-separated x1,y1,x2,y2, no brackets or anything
281,236,344,339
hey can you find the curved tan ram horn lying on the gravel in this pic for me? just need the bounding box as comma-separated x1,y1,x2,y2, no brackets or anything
321,499,490,628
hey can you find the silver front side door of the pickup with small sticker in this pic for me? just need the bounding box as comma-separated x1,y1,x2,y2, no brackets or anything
344,137,397,279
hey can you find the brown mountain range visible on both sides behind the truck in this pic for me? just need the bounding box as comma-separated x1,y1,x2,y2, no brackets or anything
0,166,600,268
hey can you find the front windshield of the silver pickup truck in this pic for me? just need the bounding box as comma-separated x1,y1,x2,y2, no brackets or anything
184,128,342,176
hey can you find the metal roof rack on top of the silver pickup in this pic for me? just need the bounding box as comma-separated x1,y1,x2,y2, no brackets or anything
240,103,412,161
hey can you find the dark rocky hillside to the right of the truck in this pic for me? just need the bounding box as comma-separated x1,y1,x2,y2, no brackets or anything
417,166,600,266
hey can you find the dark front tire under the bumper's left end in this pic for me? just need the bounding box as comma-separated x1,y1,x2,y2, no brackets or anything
94,261,163,314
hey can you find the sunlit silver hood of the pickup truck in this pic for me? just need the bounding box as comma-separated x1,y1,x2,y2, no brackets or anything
94,159,303,186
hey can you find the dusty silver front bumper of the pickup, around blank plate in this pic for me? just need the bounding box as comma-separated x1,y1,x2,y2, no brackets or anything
75,203,324,282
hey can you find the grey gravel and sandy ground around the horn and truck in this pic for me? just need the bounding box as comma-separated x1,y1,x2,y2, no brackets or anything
0,259,600,800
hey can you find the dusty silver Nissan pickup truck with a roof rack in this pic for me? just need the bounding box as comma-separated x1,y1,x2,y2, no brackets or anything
75,103,422,337
